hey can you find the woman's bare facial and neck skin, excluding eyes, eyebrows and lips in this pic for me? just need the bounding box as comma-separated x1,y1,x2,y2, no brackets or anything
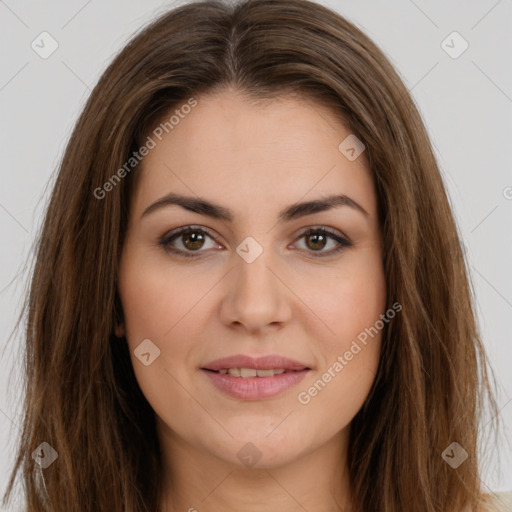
118,89,386,512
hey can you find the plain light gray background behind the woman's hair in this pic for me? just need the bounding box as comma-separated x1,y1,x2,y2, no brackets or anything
0,0,512,509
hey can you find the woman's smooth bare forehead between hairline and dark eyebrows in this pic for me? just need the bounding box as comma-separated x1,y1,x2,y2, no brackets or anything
128,91,375,220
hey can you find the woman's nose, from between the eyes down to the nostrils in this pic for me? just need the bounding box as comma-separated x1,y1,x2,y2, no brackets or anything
220,251,293,334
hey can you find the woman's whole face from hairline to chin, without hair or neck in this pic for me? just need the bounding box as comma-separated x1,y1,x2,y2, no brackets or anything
119,91,386,474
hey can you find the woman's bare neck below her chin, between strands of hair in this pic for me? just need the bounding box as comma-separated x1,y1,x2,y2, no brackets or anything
159,429,350,512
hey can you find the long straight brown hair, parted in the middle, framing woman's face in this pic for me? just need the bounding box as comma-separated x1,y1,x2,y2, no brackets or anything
4,0,497,512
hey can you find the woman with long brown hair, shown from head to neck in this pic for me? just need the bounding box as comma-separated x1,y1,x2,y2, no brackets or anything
2,0,508,512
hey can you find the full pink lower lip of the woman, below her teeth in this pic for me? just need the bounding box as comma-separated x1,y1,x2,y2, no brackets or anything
202,369,309,400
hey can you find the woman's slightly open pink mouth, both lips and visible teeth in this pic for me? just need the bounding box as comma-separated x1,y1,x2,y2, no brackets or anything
200,355,311,400
